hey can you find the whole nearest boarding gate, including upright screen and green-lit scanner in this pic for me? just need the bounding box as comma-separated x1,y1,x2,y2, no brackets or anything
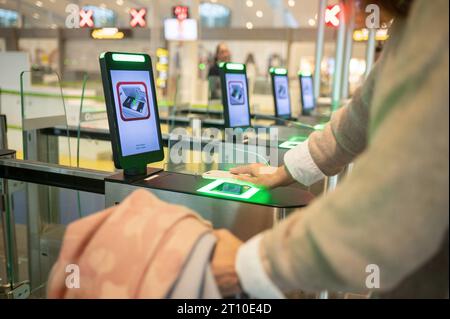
0,54,313,298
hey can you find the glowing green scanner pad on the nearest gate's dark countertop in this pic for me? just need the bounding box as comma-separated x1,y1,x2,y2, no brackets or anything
197,179,260,199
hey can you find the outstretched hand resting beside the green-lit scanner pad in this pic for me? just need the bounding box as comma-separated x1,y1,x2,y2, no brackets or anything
230,164,295,189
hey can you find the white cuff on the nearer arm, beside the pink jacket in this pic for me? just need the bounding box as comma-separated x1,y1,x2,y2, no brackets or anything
236,234,285,299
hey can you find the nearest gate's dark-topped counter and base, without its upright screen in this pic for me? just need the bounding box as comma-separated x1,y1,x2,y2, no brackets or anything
0,144,314,298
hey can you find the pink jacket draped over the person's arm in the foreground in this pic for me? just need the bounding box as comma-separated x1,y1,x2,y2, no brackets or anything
48,190,212,298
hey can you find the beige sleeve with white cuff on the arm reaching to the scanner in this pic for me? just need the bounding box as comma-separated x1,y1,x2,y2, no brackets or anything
284,55,381,180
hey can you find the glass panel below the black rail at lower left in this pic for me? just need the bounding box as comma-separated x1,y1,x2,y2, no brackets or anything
0,180,105,298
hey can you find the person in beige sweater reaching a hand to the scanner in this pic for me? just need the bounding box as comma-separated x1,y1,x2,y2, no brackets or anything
212,0,449,298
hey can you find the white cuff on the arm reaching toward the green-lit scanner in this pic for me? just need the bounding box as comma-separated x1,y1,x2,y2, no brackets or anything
284,140,325,186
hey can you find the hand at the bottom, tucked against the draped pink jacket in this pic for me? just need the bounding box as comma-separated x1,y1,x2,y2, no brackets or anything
212,229,242,297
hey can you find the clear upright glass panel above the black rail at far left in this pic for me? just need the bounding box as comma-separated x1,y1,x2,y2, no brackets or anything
18,70,72,166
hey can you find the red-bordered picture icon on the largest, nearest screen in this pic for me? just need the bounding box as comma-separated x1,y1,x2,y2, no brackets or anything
117,82,150,121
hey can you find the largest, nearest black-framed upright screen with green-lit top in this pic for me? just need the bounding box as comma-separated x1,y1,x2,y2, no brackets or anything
100,52,164,175
